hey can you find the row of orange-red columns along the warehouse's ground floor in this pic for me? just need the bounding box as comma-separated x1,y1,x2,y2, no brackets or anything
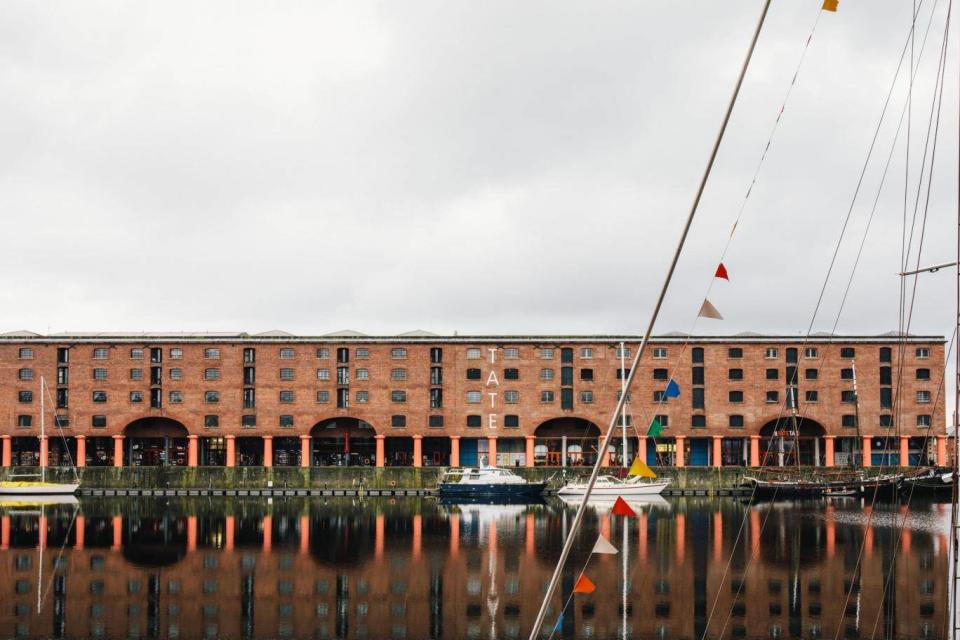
0,435,948,467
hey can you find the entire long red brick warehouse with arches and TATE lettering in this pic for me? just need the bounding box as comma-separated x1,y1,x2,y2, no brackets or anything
0,332,947,467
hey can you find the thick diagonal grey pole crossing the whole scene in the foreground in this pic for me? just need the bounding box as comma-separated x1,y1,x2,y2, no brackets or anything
530,0,771,640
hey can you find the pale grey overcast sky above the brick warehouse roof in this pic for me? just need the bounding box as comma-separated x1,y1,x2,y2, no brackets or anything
0,0,960,342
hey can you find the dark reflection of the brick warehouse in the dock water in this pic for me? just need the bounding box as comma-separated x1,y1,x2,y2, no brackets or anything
0,501,947,638
